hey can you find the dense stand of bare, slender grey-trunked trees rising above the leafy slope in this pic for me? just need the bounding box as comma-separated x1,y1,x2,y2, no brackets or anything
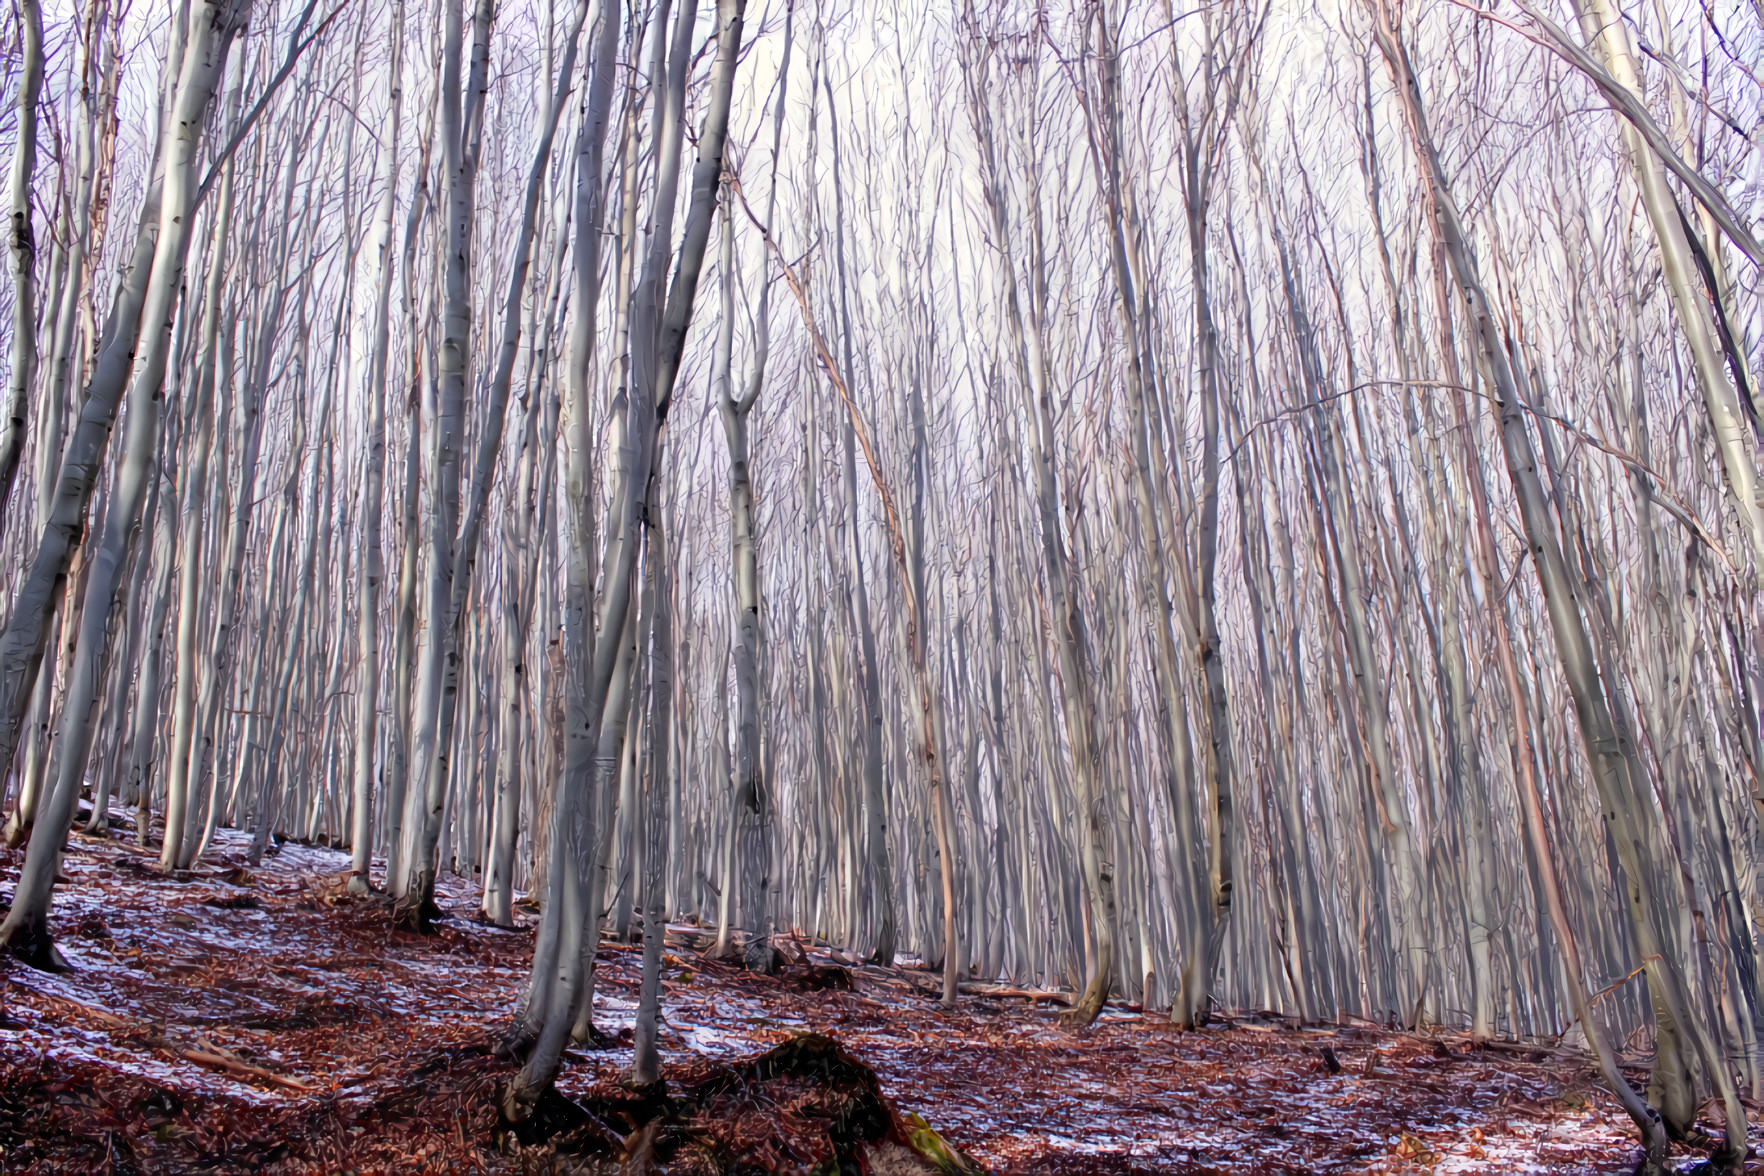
0,0,1764,1172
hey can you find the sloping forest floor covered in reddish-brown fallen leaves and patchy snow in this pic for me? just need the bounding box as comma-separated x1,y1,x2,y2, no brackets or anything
0,814,1752,1176
